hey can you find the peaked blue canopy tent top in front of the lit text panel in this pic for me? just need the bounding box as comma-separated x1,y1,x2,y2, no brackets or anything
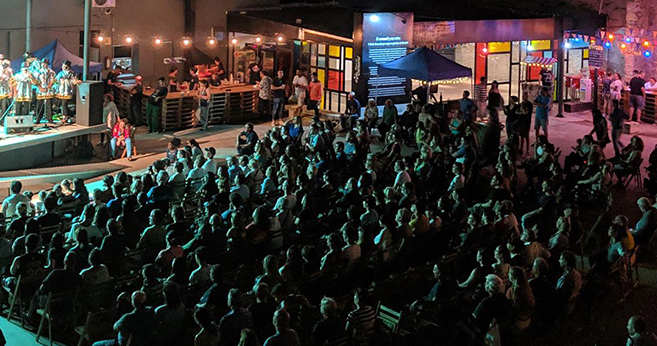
378,47,472,82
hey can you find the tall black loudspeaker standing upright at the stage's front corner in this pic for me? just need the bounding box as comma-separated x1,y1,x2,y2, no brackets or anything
75,81,105,126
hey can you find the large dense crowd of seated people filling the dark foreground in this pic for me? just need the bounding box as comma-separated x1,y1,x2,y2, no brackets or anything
0,102,657,346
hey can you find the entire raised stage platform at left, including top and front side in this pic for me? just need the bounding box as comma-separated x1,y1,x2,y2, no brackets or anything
0,124,106,171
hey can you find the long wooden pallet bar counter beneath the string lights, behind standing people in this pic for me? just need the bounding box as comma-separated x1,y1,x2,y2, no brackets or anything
115,84,258,131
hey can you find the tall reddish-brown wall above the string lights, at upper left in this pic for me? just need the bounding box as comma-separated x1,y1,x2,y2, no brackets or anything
0,0,278,84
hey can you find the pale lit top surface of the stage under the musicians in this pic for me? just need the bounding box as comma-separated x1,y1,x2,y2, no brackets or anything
0,124,106,153
